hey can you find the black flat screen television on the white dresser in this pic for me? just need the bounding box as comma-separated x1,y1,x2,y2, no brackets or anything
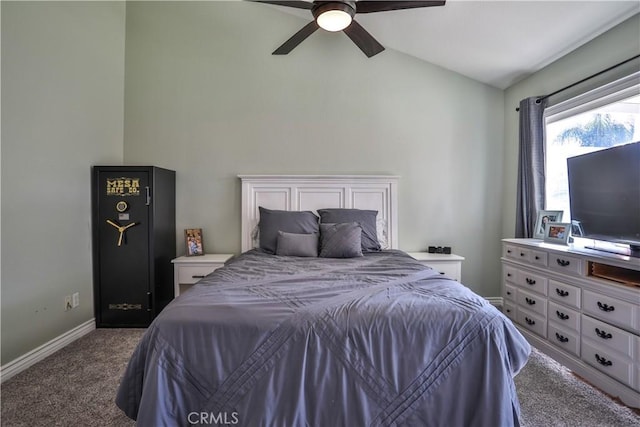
567,142,640,256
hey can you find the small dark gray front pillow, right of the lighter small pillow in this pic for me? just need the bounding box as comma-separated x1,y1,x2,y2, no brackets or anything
320,222,362,258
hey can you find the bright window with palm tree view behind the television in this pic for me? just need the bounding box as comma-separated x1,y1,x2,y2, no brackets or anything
544,73,640,221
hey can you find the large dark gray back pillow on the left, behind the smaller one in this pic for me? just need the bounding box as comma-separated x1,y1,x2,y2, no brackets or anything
258,206,320,254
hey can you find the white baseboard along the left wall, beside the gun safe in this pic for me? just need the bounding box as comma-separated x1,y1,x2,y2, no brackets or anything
0,319,96,384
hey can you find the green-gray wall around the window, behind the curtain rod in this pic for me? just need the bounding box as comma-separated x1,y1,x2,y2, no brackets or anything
502,15,640,237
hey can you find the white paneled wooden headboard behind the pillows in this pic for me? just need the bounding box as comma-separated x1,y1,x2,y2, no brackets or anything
238,175,399,252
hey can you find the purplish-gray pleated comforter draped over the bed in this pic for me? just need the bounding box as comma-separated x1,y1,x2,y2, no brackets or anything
116,251,530,427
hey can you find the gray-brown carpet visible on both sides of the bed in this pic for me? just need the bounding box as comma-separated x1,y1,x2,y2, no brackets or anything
0,329,640,427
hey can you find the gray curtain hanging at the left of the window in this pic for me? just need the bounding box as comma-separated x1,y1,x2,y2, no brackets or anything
516,96,546,237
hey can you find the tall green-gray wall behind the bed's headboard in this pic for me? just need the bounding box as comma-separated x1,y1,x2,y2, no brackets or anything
125,2,504,296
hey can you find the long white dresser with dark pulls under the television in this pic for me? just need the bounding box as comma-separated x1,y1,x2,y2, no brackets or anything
502,239,640,407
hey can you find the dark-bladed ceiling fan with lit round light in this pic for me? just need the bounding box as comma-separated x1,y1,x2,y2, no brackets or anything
254,0,445,58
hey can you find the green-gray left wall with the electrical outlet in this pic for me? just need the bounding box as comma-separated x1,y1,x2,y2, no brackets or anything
1,1,125,364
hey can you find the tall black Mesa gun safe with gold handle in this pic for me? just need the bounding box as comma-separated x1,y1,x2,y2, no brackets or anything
91,166,176,327
